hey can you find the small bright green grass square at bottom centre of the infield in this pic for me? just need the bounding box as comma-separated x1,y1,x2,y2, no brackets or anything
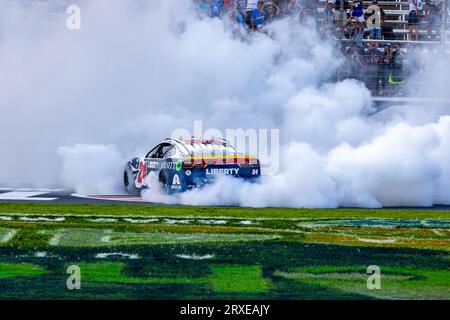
211,265,269,293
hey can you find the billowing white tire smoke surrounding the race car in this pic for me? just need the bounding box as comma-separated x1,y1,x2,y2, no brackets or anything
0,0,450,207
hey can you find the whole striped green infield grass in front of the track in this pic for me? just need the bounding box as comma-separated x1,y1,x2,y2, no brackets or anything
0,204,450,300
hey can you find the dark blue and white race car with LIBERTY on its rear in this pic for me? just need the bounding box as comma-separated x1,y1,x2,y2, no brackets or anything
123,138,261,195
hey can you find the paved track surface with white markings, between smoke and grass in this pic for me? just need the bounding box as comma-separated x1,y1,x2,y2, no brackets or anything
0,188,450,210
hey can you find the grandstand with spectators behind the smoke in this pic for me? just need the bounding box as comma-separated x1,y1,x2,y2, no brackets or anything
0,0,450,100
